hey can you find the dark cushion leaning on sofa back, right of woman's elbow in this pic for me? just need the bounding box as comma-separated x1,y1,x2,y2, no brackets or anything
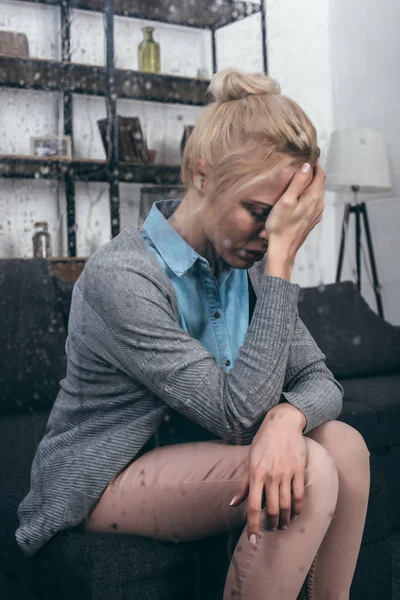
299,281,400,378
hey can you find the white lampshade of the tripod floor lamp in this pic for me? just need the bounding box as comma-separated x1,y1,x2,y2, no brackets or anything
325,129,392,193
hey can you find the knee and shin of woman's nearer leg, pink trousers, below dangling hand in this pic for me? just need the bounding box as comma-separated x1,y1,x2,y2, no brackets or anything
224,438,338,600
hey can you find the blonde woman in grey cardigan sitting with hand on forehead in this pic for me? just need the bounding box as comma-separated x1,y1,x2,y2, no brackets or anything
16,70,369,600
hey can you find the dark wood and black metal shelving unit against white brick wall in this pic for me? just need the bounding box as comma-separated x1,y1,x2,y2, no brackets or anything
0,0,268,257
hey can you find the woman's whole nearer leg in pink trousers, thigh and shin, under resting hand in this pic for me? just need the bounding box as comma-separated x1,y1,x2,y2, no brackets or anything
85,439,338,600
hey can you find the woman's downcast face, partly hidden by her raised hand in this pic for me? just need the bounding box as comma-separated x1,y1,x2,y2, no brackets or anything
203,165,299,269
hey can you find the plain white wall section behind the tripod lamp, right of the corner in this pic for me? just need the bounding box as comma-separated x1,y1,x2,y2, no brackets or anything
330,0,400,324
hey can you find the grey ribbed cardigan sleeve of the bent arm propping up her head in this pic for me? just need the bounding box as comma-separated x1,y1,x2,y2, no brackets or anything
77,253,300,443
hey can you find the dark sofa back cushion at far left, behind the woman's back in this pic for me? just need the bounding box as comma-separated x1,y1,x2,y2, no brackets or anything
0,259,66,415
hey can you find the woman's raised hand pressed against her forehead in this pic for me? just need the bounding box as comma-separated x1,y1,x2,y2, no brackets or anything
265,163,326,264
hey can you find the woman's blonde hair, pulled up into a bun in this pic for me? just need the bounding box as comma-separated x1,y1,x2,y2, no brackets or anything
182,69,320,193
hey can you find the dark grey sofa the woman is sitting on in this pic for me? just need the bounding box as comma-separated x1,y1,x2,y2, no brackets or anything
0,259,400,600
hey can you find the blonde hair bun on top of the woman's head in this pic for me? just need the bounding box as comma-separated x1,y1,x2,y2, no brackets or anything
208,69,281,103
